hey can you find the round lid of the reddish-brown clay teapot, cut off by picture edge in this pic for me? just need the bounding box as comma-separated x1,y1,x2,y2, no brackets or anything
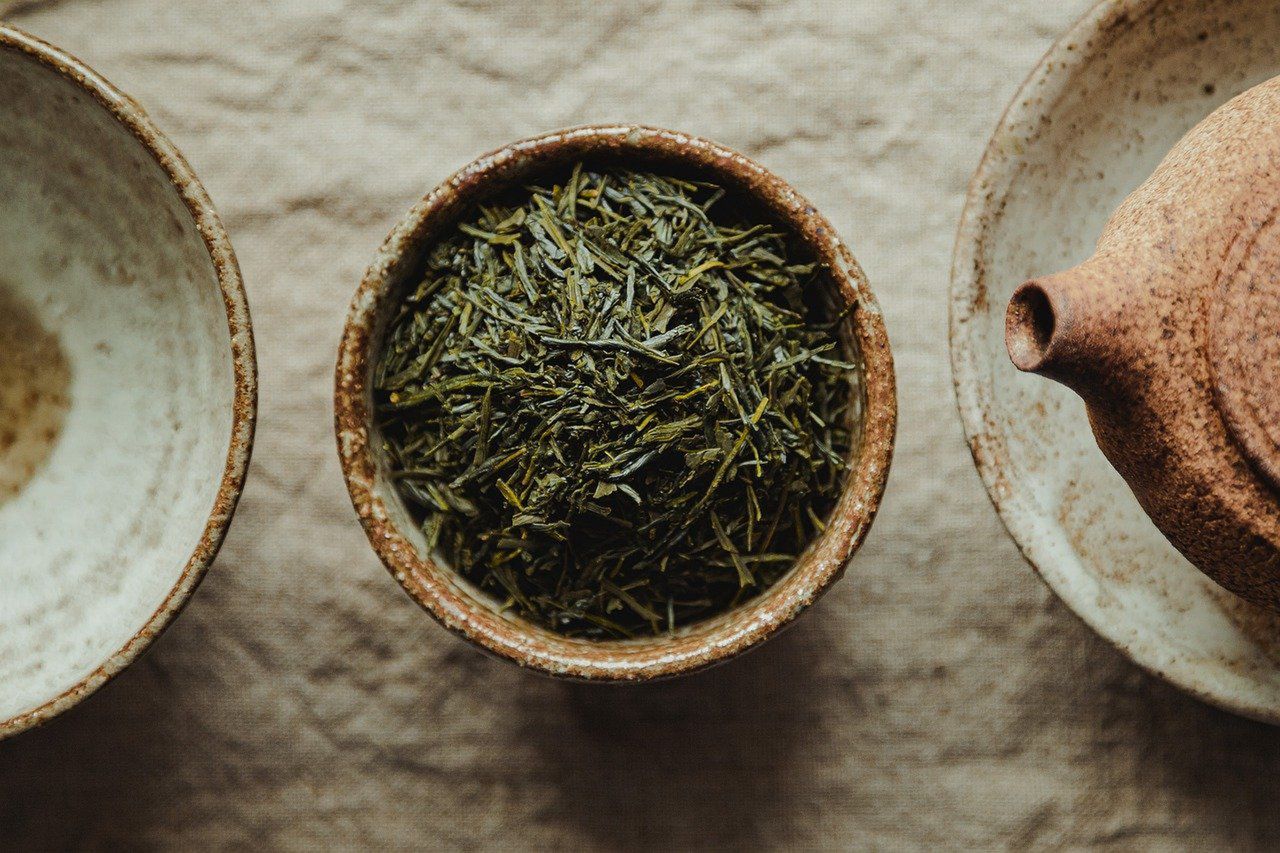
1207,210,1280,491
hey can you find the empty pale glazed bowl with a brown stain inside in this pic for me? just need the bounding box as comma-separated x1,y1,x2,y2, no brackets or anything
0,26,256,736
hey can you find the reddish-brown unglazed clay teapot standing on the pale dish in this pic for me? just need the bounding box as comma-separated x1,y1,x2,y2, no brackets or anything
1005,78,1280,610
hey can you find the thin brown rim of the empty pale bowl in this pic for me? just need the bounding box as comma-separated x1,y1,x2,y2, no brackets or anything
0,23,257,739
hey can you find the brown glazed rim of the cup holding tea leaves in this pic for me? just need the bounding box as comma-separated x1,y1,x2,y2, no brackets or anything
334,126,897,681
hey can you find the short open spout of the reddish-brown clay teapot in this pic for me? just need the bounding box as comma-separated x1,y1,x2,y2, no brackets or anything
1005,261,1133,402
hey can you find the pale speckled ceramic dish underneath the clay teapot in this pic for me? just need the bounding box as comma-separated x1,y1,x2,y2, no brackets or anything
951,0,1280,722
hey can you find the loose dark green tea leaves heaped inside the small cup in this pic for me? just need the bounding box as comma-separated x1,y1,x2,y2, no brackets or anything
375,165,858,639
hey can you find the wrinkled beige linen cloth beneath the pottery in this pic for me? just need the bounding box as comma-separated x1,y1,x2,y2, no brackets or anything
0,0,1280,850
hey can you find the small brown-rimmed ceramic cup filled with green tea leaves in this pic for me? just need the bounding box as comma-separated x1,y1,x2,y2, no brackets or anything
335,126,896,681
